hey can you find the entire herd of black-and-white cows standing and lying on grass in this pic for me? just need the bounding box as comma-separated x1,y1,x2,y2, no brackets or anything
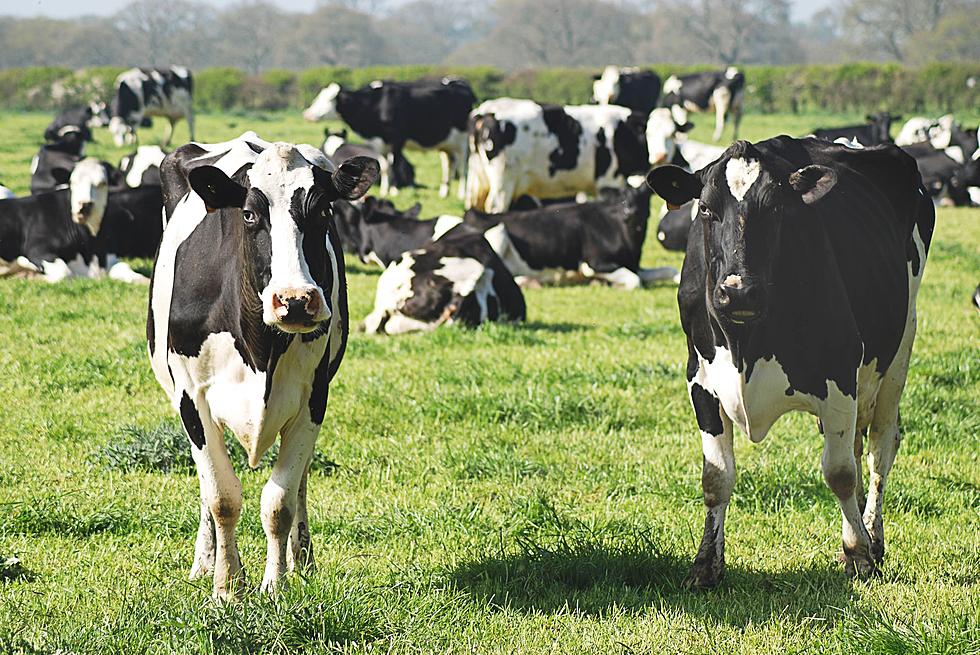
0,67,968,597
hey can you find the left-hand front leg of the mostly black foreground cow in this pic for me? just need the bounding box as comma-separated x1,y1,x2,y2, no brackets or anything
686,402,735,589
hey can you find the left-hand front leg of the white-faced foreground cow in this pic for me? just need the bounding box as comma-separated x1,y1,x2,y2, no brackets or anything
180,408,245,600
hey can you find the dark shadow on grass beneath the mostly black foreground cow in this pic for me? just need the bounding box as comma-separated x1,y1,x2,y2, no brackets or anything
449,548,852,627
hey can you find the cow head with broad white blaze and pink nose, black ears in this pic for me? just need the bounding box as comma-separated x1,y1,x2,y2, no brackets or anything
188,143,379,333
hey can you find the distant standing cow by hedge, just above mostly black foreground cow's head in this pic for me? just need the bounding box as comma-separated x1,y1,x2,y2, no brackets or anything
660,66,745,141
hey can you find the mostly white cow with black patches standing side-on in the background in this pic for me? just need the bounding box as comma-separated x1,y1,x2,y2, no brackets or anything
465,98,664,213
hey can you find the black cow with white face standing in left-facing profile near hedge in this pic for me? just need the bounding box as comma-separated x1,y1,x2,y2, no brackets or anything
303,77,476,198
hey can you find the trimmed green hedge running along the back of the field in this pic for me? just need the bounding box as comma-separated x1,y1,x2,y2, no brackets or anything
0,62,980,114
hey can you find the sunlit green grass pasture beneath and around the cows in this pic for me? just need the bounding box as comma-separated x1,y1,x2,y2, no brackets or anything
0,113,980,655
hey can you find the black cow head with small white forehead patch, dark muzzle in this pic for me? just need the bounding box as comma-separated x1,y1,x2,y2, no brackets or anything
647,141,837,326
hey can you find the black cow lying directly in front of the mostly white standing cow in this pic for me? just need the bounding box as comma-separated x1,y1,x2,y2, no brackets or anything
464,185,677,289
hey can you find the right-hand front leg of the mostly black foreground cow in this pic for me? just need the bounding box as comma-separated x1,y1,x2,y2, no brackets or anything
820,397,875,577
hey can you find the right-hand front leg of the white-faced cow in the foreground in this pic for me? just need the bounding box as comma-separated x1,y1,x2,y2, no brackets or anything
262,417,319,593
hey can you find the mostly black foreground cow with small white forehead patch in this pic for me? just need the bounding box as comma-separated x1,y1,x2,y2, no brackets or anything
648,136,935,588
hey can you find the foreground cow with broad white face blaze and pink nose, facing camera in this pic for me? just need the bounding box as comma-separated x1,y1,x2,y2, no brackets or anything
146,133,378,599
